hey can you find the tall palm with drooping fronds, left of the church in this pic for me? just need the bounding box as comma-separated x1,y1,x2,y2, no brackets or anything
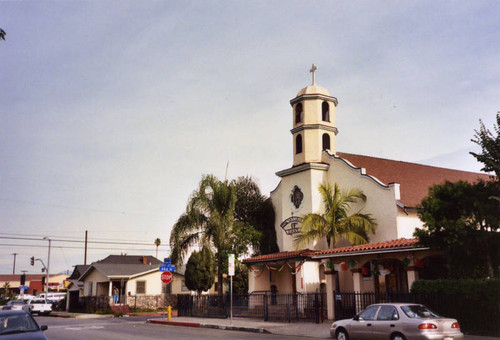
170,175,236,295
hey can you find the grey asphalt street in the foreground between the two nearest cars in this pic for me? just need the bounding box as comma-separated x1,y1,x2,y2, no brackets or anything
35,316,326,340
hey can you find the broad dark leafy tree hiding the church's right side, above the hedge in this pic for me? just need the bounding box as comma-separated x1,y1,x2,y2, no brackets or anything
414,181,500,278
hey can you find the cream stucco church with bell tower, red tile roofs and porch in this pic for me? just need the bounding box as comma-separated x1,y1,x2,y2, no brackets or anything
243,65,489,319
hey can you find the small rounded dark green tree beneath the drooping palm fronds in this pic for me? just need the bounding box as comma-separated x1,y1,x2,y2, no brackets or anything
184,247,215,295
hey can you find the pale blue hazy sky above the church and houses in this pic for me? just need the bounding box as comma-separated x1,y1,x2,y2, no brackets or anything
0,0,500,274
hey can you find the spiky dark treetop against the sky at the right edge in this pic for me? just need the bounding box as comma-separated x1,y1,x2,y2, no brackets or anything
470,113,500,178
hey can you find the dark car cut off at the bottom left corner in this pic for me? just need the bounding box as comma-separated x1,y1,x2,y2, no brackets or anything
0,310,48,340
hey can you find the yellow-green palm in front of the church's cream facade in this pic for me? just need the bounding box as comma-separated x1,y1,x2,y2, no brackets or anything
295,183,377,249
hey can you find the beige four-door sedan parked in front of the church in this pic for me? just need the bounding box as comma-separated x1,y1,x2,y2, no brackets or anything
330,303,464,340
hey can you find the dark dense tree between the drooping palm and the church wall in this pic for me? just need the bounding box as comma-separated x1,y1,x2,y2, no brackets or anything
234,176,279,255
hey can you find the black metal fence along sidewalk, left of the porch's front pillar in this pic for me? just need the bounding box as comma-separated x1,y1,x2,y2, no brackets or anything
177,293,327,323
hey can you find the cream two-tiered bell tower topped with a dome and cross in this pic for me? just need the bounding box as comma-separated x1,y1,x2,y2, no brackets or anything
290,64,338,166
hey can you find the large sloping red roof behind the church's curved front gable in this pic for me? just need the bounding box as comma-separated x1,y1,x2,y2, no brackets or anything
337,152,490,207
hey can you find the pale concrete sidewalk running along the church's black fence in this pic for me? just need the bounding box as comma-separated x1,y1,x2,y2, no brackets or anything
148,316,500,340
